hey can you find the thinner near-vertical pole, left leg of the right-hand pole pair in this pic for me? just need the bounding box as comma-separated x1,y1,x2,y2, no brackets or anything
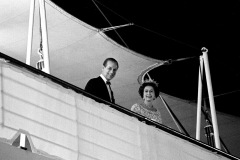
196,56,203,140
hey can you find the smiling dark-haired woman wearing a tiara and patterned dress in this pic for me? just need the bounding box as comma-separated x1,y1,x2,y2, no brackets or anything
131,80,162,123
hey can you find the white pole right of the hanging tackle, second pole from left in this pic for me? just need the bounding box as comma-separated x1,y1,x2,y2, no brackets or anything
39,0,50,74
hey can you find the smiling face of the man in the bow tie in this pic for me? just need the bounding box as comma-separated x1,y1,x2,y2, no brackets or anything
102,61,118,81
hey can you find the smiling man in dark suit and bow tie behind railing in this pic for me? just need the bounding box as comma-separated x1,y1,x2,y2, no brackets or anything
85,58,119,103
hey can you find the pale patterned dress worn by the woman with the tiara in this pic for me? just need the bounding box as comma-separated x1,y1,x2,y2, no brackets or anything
131,103,162,124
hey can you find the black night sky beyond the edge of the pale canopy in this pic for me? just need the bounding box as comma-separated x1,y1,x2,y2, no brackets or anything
53,0,240,116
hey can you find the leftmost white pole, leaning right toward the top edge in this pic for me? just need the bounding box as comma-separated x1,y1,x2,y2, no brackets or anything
26,0,35,65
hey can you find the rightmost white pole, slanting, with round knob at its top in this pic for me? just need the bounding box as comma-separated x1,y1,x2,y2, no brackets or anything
202,47,221,149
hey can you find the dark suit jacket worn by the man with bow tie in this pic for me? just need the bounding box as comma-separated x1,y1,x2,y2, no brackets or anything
85,76,115,103
